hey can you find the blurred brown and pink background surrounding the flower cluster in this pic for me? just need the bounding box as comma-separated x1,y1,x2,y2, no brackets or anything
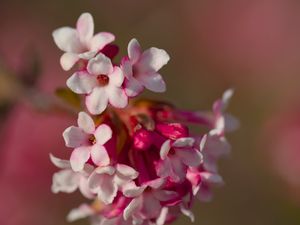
0,0,300,225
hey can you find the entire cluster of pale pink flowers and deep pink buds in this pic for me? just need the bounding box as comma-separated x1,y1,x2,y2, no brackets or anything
50,13,236,225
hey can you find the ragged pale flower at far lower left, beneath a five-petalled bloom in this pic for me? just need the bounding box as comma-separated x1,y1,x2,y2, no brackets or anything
50,154,94,198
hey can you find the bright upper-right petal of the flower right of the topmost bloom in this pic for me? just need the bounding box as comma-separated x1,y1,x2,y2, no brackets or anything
138,48,170,72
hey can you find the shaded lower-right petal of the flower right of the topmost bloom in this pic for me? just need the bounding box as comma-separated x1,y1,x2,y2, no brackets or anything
137,73,166,92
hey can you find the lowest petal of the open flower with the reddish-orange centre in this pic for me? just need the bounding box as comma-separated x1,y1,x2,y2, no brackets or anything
85,87,108,115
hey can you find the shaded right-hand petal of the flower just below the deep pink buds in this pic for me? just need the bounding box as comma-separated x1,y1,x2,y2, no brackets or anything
176,149,203,167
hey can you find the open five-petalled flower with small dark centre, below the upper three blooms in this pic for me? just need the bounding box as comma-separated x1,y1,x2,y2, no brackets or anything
63,112,112,171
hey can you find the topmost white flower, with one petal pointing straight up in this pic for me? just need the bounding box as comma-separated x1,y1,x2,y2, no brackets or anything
52,13,115,70
